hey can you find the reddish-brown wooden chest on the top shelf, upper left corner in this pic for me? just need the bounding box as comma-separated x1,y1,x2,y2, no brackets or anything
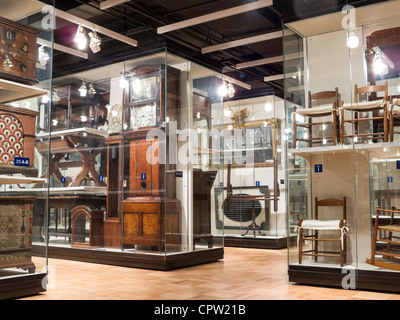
0,17,40,85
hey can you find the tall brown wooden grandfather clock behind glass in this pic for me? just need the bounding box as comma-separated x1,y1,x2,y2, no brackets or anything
122,64,181,251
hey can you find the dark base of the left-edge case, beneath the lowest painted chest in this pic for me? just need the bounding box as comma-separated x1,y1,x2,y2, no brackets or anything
0,271,46,300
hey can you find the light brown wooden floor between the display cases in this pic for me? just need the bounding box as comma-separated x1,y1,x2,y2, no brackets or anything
23,248,400,300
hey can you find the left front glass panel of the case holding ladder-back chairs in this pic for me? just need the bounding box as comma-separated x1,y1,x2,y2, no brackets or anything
284,11,356,268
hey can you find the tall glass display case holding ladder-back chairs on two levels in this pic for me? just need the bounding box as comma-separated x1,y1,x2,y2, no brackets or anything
283,1,400,292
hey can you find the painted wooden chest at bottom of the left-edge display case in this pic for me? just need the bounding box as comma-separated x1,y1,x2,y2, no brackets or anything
0,197,35,273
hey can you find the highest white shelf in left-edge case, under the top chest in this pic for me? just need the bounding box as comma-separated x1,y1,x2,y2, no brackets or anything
0,79,47,103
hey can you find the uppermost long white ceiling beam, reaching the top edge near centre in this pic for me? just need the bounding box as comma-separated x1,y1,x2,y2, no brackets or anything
157,0,273,34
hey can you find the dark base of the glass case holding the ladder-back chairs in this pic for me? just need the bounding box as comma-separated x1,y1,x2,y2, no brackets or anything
288,266,400,293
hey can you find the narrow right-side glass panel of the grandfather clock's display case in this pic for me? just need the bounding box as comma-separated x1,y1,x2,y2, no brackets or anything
167,54,223,253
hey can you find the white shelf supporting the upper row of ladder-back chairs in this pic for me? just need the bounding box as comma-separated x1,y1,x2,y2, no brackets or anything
288,142,400,159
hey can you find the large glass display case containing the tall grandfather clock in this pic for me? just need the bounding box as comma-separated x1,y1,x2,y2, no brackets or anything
35,48,224,270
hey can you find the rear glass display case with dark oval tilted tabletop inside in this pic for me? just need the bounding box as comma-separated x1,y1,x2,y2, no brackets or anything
215,95,287,249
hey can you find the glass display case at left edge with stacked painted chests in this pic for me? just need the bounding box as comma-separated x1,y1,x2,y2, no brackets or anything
0,1,53,299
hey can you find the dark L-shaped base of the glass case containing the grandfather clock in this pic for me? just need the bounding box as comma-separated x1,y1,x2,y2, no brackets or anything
33,245,224,271
